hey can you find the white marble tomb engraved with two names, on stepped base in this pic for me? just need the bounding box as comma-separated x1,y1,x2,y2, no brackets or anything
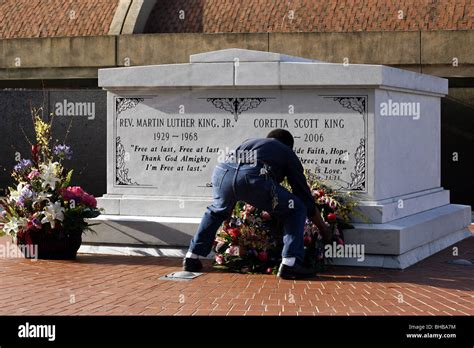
82,49,471,269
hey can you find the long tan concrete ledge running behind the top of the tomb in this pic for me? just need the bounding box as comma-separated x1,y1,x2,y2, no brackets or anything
0,30,474,79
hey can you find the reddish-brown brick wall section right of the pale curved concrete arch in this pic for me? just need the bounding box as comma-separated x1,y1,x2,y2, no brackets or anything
145,0,474,33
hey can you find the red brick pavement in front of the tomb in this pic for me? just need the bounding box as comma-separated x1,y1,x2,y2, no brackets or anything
0,232,474,315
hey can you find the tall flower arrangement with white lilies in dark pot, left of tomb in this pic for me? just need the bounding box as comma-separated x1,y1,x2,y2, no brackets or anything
0,109,100,258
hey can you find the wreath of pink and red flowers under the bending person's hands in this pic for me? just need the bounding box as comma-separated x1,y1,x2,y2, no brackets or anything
214,170,357,274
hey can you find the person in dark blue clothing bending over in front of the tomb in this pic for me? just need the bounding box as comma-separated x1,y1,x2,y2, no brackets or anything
183,129,331,279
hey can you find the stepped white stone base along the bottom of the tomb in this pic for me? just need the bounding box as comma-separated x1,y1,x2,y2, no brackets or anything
80,197,471,269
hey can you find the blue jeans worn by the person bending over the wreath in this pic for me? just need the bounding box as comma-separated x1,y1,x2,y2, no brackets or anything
189,163,307,261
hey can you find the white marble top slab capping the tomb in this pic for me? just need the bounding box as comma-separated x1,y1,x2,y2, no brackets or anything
99,49,448,96
